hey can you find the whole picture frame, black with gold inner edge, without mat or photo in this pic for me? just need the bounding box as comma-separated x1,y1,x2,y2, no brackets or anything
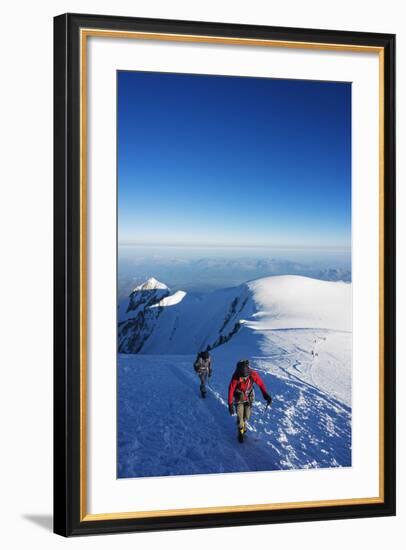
54,14,396,536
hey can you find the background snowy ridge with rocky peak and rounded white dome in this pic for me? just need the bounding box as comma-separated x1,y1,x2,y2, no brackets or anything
118,275,351,354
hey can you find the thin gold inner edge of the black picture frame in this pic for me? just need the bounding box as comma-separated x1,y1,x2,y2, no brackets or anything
80,28,385,522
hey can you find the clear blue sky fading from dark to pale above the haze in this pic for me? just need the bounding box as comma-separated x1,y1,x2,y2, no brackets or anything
118,71,351,247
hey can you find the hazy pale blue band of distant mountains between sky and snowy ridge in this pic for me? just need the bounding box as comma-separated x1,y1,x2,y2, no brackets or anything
118,245,351,298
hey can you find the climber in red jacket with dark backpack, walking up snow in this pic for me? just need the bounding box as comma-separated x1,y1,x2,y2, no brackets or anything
228,359,272,443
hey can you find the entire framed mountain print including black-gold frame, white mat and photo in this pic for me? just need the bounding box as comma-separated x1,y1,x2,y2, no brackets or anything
54,14,395,536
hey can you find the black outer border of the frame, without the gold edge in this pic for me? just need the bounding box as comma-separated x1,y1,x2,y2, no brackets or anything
54,14,396,536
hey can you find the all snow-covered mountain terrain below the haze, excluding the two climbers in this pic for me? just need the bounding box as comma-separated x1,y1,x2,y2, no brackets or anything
118,276,351,477
